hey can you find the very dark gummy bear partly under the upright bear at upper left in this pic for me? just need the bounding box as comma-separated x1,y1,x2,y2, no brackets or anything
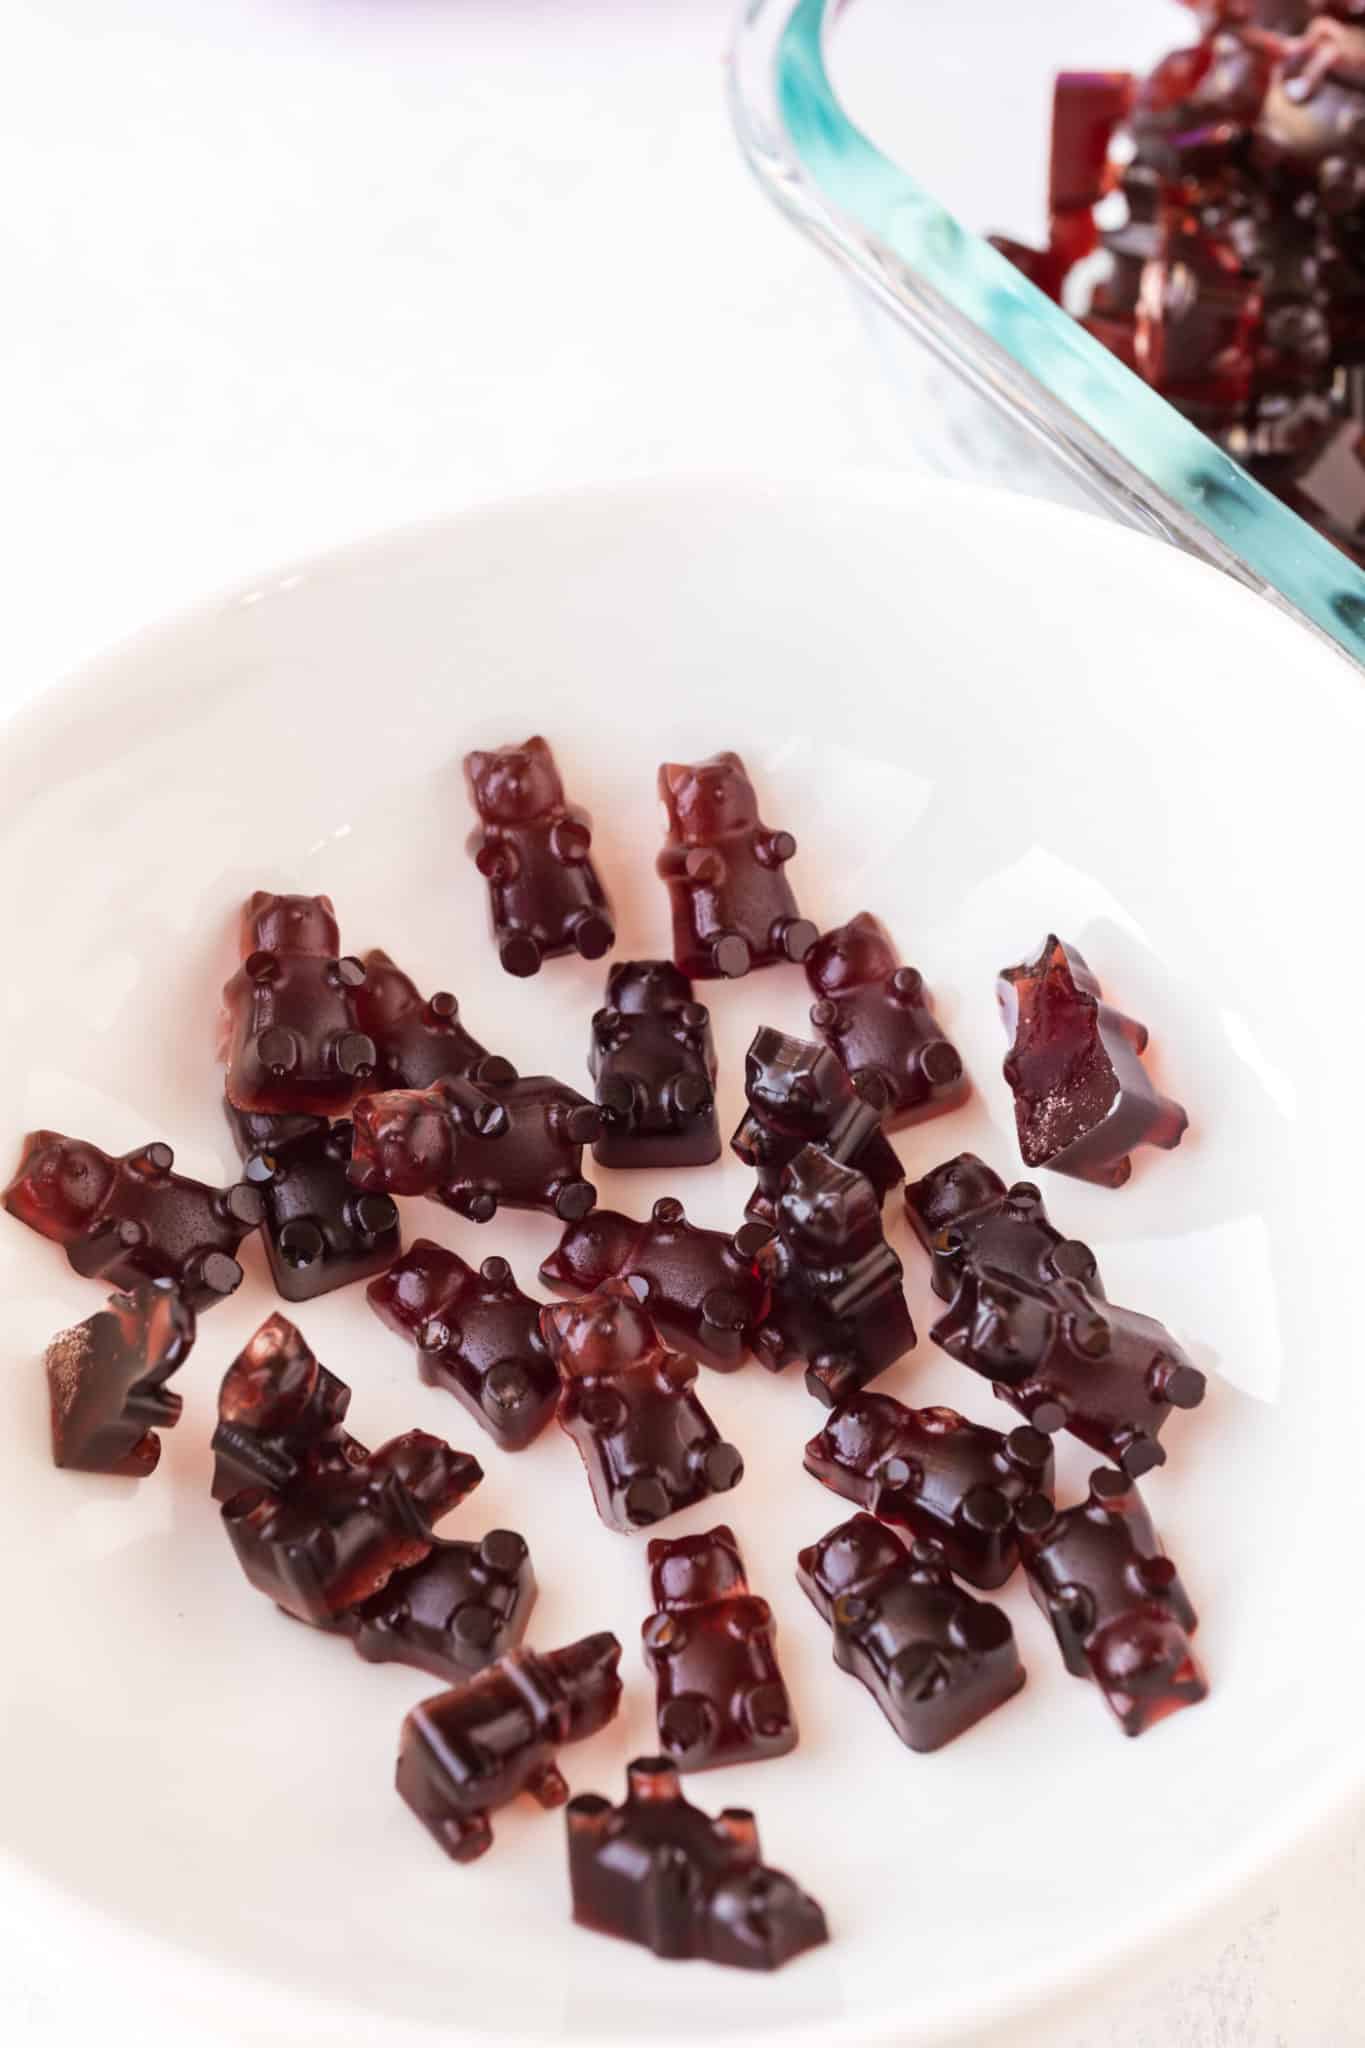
225,1102,403,1300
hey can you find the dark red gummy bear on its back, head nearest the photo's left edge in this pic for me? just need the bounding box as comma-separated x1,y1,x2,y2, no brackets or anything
4,1130,264,1311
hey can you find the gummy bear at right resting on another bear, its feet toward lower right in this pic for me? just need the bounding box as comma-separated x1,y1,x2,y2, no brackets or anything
931,1266,1205,1479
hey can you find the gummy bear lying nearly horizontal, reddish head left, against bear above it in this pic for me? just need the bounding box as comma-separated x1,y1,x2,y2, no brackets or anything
350,1073,602,1223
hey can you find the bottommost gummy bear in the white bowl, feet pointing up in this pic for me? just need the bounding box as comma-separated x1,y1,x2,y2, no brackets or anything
567,1757,829,1970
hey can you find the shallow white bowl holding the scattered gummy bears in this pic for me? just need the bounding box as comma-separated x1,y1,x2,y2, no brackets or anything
0,481,1365,2048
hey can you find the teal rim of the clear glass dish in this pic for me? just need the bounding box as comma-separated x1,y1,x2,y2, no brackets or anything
765,0,1365,662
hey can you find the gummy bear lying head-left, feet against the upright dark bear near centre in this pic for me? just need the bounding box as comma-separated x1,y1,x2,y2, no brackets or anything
540,1194,767,1372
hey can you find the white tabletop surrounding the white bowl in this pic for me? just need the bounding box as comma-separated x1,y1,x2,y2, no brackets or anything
0,0,1365,2048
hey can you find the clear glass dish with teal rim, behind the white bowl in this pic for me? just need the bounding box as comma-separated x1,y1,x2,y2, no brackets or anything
729,0,1365,662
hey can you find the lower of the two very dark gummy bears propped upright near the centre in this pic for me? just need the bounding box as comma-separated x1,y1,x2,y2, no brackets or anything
753,1145,915,1407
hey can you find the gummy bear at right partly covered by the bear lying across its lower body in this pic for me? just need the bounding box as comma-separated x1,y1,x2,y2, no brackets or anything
905,1153,1105,1300
